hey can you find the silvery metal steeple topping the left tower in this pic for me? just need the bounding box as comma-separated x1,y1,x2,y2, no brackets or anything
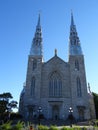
30,14,42,57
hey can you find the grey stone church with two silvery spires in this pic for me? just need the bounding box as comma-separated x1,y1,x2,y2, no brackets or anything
19,13,95,120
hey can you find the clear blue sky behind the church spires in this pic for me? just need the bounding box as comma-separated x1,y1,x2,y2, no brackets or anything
0,0,98,110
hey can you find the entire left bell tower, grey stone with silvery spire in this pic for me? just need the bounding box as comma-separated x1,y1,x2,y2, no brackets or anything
19,14,43,120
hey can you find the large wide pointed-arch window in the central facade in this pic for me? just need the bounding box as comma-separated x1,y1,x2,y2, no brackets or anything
49,71,62,97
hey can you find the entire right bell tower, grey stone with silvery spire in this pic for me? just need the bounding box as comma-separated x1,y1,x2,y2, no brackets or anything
69,12,90,120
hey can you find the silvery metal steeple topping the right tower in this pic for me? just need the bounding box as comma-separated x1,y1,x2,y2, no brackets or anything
69,12,82,55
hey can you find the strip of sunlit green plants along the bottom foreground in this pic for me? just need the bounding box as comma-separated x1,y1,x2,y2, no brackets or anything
0,121,98,130
